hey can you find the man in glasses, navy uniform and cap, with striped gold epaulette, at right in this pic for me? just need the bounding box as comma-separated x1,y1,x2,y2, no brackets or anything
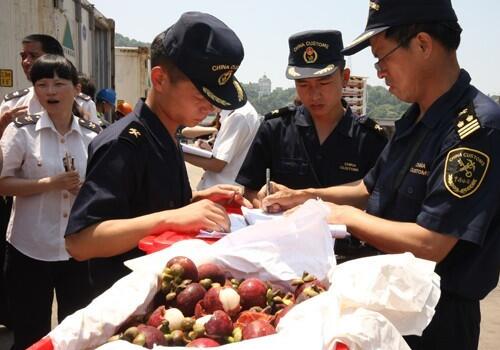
264,0,500,350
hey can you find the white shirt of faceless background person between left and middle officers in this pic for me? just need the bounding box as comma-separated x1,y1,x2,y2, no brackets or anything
197,102,262,190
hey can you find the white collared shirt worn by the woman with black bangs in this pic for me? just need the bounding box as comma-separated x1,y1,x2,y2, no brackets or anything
0,112,97,261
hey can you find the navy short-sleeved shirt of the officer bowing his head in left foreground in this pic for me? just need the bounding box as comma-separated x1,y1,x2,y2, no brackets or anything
66,101,191,294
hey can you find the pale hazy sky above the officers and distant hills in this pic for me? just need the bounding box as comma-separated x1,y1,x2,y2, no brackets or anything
89,0,500,95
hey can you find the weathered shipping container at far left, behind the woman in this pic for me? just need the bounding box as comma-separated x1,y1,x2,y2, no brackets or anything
0,0,114,97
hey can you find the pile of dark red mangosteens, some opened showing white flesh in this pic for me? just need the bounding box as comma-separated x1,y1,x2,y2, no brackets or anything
105,256,327,349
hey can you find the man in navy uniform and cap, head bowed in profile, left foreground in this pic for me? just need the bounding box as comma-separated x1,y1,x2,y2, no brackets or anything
66,12,250,294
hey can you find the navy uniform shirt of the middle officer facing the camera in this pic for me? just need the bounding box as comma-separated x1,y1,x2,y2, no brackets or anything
236,106,387,190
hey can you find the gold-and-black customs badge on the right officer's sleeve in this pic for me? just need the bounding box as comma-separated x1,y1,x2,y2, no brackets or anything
443,147,490,198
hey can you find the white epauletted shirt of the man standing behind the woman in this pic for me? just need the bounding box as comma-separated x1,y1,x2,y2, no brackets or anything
0,86,99,124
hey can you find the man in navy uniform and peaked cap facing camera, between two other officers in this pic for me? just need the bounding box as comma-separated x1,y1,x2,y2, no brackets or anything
236,30,387,258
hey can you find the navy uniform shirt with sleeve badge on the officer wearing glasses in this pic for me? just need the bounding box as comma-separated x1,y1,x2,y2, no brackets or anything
364,70,500,300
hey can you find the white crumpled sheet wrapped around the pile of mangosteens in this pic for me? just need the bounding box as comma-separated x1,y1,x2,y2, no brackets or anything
50,201,439,350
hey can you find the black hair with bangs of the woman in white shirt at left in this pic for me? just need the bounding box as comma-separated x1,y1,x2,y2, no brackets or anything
30,54,79,86
